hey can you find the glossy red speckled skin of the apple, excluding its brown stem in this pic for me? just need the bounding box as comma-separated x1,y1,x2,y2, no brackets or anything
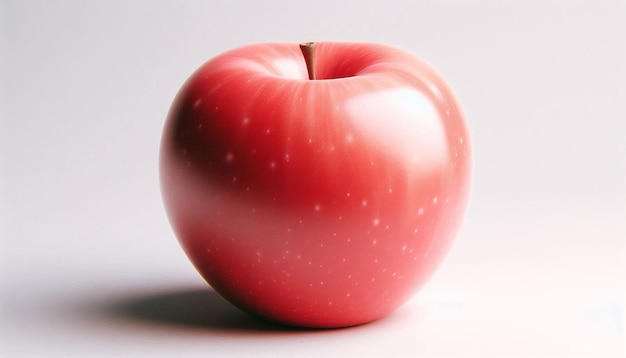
160,42,472,328
